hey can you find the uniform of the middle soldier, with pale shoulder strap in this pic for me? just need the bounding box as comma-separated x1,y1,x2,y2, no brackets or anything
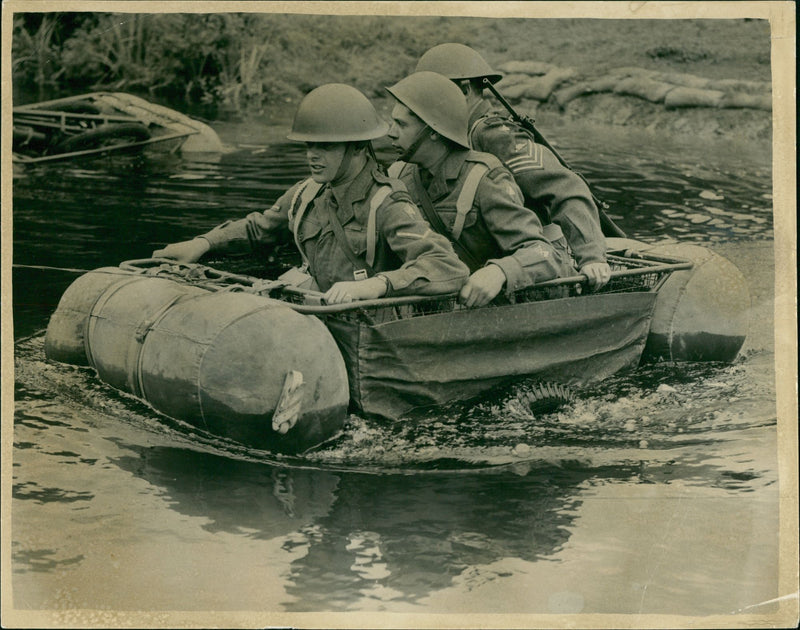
390,149,574,293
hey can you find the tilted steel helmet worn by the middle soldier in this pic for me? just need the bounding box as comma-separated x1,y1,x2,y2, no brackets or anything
386,72,469,149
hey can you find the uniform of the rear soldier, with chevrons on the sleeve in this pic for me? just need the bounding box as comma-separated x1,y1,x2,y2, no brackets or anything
469,100,606,267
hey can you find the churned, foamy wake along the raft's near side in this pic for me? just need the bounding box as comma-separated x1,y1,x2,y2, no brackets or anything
16,334,776,473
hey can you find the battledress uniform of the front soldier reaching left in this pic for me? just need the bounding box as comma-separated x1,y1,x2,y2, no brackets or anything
202,160,468,295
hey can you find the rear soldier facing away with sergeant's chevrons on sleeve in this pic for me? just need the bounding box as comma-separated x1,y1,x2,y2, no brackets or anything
416,44,611,289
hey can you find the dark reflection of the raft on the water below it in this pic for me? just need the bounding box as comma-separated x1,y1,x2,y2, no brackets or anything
108,448,608,611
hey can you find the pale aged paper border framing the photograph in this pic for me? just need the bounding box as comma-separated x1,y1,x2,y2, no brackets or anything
0,0,798,628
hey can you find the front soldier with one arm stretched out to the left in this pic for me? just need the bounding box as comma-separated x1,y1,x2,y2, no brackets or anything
153,84,468,304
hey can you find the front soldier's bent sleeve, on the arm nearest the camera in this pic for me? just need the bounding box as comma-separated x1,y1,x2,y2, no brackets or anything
377,192,469,295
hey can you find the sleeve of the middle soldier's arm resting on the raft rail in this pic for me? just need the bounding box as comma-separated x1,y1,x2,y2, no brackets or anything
476,168,561,293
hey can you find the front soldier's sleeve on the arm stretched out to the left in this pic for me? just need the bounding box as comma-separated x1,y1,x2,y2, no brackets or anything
200,184,300,254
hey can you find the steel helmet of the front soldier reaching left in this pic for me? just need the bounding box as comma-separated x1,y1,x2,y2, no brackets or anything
286,83,389,142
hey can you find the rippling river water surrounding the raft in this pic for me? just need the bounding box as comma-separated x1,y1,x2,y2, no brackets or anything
11,119,781,627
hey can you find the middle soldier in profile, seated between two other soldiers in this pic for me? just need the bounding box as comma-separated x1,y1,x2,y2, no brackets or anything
386,72,574,306
